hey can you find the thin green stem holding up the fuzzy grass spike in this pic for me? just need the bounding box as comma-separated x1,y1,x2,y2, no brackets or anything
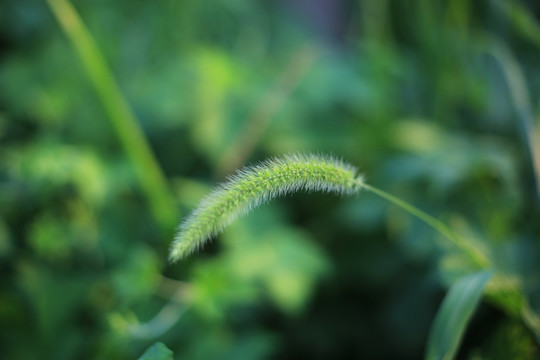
362,183,490,269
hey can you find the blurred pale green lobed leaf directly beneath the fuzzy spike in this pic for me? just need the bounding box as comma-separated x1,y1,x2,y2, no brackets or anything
224,205,330,313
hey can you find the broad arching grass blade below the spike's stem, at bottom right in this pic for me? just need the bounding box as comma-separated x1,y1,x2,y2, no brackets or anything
425,271,492,360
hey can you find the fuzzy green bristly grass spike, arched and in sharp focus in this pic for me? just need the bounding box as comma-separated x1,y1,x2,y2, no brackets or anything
170,154,363,262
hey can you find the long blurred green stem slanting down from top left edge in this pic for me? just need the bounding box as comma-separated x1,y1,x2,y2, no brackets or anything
47,0,179,231
